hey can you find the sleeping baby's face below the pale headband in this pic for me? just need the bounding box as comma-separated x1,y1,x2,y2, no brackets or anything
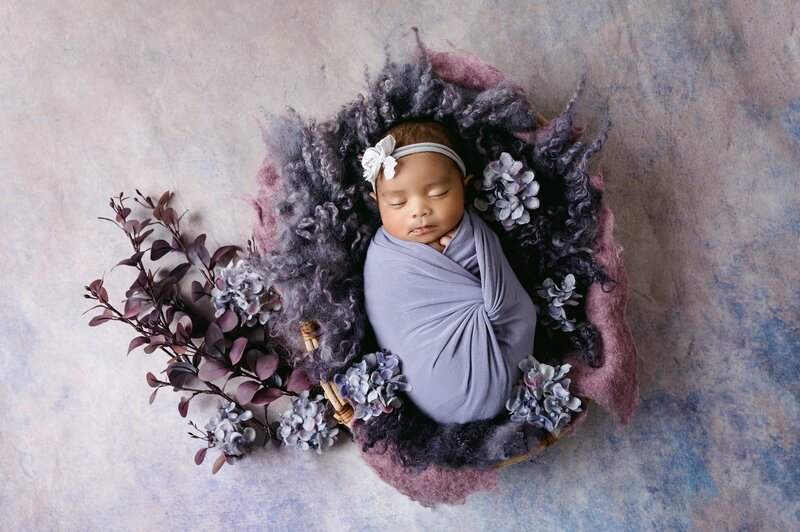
370,152,472,244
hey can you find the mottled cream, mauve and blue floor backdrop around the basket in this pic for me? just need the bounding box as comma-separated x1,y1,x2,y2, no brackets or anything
0,0,800,530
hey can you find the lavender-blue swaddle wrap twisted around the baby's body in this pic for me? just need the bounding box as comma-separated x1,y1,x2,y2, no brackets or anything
364,207,536,423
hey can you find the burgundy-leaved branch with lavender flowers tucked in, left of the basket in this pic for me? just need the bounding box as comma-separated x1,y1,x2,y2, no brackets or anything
84,190,311,472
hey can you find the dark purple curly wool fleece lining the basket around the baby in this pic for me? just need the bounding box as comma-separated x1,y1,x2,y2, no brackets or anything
255,31,610,470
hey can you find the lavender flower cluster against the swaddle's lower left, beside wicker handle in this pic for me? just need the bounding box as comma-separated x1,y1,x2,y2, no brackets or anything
333,351,411,421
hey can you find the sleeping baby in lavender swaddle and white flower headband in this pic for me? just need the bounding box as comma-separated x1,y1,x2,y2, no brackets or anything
361,122,536,423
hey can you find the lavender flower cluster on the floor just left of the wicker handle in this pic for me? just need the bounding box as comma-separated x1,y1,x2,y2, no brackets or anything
278,390,339,454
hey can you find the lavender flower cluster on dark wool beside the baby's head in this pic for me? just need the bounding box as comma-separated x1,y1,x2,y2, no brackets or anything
473,152,539,231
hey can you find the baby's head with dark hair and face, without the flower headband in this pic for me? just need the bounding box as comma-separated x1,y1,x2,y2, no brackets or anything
370,121,472,244
